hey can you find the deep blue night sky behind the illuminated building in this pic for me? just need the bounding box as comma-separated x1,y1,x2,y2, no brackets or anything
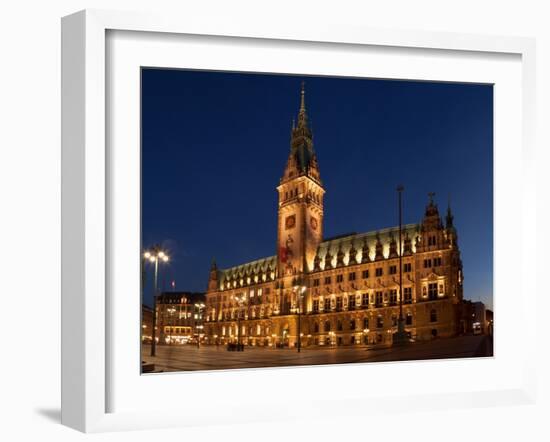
142,69,493,308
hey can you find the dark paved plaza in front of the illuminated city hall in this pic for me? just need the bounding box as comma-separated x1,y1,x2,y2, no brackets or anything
142,336,493,372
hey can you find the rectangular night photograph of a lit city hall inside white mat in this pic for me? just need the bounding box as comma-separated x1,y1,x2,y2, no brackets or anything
140,68,494,373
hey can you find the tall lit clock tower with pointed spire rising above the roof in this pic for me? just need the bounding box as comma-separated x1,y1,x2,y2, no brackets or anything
277,83,325,277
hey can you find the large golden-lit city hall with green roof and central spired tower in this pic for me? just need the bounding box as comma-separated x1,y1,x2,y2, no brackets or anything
205,87,465,347
